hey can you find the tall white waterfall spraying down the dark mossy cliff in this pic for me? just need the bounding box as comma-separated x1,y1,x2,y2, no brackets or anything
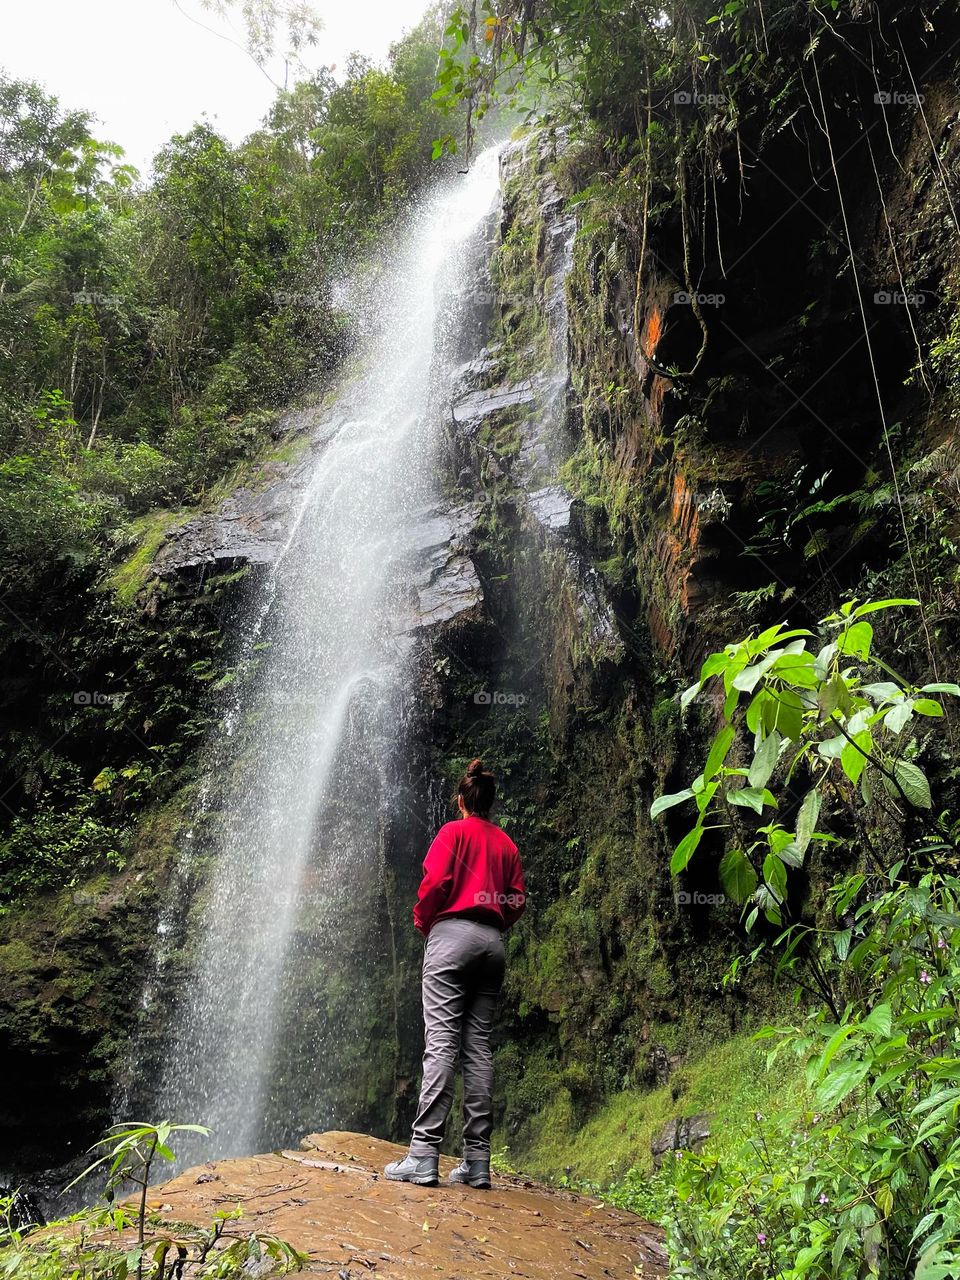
156,148,497,1160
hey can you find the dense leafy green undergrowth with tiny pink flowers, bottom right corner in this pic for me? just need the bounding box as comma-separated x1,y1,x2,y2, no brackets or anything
666,868,960,1280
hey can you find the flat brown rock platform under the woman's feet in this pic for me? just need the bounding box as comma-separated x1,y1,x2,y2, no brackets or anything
148,1133,667,1280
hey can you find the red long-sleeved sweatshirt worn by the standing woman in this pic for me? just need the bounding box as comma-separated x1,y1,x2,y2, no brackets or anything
413,814,526,934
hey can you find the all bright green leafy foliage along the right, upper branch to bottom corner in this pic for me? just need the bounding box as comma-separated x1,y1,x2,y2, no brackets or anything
652,600,960,1280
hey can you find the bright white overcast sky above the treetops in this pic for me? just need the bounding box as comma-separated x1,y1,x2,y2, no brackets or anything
0,0,428,177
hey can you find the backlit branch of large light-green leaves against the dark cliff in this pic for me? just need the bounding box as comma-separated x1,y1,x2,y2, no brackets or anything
650,600,960,929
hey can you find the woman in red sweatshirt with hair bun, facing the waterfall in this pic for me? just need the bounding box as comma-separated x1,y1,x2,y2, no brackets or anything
384,760,525,1188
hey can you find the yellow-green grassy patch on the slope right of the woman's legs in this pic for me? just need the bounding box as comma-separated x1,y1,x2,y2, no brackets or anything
512,1034,803,1187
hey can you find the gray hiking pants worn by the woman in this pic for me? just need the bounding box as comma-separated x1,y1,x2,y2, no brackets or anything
410,916,504,1160
